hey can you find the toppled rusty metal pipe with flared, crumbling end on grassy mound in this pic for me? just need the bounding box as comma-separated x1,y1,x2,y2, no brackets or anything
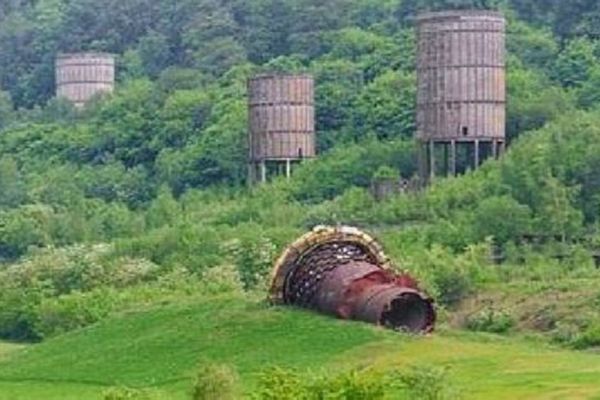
271,227,436,333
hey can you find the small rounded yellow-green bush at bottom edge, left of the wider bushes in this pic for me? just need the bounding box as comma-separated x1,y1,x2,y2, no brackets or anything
192,364,238,400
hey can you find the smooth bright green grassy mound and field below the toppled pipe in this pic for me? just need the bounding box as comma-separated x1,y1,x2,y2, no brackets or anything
0,298,600,400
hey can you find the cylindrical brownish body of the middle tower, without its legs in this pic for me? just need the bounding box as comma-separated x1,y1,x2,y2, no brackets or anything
248,74,316,162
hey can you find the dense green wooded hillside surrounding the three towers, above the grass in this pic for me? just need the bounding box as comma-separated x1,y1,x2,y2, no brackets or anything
0,0,600,362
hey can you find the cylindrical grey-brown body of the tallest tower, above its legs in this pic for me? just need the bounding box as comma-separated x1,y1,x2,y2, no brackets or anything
417,10,506,141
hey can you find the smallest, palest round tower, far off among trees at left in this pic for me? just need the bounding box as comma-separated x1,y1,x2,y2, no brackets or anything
55,53,115,108
